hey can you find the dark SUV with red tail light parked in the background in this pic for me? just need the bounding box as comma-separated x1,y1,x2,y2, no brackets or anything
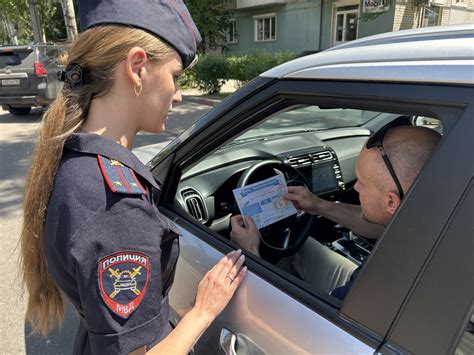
0,43,66,116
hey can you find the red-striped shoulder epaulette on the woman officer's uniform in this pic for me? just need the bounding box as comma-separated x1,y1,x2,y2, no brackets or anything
97,155,147,195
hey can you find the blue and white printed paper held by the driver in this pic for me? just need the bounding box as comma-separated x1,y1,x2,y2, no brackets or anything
233,174,297,229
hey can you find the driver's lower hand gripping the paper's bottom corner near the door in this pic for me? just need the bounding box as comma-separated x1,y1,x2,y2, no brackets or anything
230,215,260,256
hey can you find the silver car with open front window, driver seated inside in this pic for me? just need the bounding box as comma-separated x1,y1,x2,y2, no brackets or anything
150,25,474,354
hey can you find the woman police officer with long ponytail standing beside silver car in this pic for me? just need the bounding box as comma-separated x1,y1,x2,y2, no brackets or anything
21,0,246,354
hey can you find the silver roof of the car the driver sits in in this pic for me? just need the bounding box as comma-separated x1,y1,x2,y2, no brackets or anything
261,24,474,85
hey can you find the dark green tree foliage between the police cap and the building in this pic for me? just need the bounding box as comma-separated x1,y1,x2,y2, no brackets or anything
184,0,232,53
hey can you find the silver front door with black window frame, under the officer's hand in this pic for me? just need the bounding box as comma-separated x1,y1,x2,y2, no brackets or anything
151,78,468,354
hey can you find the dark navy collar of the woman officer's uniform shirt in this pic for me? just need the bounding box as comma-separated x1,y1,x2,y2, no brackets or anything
65,132,159,189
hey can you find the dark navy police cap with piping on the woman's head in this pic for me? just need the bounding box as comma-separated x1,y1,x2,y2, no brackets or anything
79,0,201,68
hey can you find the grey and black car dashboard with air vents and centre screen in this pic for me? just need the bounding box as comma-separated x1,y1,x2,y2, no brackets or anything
176,127,370,242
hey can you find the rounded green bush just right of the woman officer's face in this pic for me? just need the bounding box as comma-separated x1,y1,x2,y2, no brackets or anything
191,54,228,94
